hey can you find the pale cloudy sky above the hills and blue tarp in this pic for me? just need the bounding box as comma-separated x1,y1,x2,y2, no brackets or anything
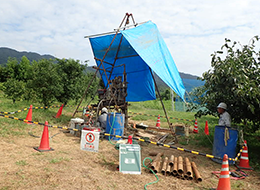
0,0,260,76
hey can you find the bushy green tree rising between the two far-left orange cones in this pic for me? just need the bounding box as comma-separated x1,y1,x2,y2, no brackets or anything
29,59,63,106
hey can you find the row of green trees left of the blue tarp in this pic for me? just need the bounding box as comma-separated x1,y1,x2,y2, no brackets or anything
0,56,101,106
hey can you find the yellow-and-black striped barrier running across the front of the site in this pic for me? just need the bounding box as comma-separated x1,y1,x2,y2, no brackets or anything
0,114,245,161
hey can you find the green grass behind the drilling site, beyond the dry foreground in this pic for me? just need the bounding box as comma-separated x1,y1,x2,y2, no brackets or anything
0,96,260,169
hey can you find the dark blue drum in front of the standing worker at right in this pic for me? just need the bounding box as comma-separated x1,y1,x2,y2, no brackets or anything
212,126,238,164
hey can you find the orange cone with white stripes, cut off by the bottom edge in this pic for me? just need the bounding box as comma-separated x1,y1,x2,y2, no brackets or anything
217,154,231,190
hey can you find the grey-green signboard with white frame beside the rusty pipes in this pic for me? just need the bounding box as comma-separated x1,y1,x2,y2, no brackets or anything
119,144,141,174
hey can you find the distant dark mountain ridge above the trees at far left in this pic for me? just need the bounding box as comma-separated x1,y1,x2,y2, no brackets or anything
0,47,55,65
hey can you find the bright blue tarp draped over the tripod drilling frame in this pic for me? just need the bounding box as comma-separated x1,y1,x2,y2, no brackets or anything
89,21,185,102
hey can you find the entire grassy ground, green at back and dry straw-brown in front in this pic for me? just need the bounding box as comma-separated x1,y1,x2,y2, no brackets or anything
0,96,260,190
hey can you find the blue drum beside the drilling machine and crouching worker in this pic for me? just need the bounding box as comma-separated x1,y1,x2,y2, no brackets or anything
106,112,125,141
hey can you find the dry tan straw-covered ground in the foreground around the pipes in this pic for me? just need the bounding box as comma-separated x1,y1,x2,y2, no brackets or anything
0,124,260,190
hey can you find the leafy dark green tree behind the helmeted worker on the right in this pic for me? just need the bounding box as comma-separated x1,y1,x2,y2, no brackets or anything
191,36,260,132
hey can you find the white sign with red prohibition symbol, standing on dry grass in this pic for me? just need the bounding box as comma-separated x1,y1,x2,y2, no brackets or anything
80,130,100,152
